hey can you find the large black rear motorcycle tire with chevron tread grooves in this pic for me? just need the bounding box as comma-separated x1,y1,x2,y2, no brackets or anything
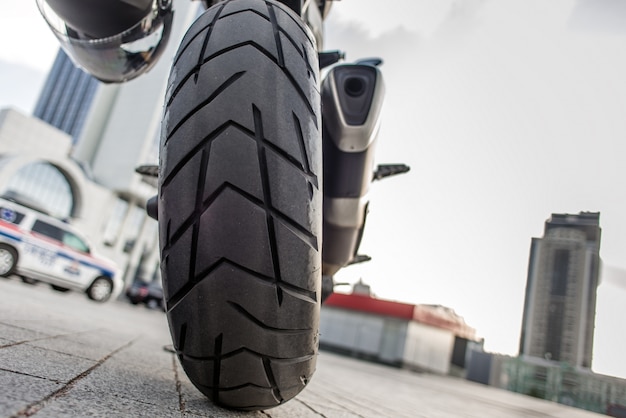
158,0,322,410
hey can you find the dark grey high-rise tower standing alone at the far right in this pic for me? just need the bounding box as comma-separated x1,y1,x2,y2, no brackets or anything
520,212,601,368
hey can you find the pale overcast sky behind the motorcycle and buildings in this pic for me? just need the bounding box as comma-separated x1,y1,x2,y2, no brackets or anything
0,0,626,377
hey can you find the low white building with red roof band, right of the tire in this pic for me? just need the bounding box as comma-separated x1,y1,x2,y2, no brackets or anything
320,283,482,374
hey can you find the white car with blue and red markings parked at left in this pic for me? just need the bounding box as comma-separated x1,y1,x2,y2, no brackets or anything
0,198,122,302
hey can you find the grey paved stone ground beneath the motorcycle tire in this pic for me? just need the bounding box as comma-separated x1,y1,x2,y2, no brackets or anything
0,278,601,418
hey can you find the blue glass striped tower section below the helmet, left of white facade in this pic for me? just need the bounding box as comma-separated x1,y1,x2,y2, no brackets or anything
33,49,99,143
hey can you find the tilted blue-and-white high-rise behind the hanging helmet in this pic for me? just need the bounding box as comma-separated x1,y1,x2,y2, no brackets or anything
29,2,202,189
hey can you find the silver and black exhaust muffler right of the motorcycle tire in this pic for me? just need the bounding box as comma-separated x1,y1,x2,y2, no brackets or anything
321,64,385,276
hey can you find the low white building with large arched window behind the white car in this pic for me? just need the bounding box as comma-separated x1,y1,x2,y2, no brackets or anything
0,109,125,296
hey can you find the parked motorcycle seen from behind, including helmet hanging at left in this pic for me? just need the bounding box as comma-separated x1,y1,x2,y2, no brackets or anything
37,0,408,410
